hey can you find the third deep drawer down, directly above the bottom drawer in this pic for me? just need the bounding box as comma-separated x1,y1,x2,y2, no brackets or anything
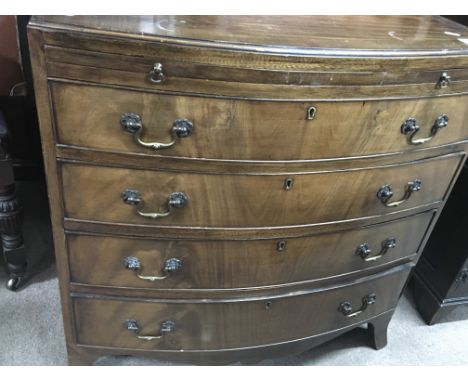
67,211,434,289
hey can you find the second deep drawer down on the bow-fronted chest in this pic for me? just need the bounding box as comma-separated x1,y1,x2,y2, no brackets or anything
62,153,465,228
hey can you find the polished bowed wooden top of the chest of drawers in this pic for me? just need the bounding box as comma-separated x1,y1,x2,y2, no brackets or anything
31,16,468,56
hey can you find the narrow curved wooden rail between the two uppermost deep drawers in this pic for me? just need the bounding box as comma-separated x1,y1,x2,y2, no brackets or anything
56,139,468,176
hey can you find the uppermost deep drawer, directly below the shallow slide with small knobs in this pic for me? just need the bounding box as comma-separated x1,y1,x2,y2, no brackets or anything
50,83,468,161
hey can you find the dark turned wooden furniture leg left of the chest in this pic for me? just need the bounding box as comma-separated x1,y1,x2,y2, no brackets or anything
0,112,26,291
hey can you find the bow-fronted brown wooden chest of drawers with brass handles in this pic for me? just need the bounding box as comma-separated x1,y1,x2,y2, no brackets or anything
29,16,468,364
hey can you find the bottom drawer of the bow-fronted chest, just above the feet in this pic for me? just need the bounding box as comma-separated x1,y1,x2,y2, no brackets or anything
73,265,411,351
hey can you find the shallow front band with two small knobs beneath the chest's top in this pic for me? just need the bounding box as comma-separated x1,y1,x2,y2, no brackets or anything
44,42,468,100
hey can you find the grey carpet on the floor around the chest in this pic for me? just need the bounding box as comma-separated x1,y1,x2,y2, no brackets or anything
0,183,468,365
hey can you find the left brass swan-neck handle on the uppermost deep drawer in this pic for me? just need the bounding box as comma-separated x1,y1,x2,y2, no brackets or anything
120,113,194,150
